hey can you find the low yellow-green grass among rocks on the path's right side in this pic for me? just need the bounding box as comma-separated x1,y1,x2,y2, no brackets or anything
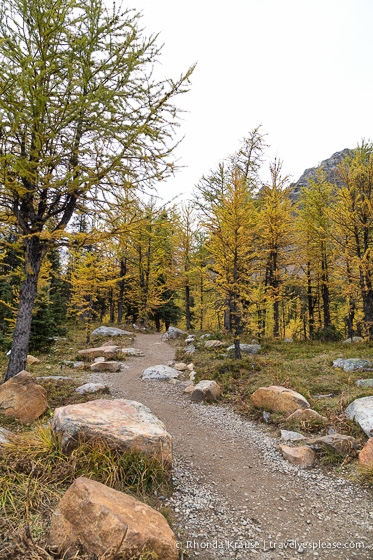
177,337,373,483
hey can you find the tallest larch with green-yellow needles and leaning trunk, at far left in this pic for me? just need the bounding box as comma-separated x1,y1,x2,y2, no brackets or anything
0,0,192,379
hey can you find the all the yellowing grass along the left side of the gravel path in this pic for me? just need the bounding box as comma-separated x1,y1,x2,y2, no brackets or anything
0,324,172,560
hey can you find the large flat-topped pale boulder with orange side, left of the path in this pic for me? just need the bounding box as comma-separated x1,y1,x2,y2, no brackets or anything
52,399,172,466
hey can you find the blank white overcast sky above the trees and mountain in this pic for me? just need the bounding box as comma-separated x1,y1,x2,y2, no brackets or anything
133,0,373,199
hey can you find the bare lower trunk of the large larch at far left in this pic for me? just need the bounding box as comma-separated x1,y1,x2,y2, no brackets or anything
4,236,46,381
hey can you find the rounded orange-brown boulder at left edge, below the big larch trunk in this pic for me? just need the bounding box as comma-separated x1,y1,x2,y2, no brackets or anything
0,370,48,424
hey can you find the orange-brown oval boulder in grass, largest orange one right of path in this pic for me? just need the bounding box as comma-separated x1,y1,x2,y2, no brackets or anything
251,385,310,414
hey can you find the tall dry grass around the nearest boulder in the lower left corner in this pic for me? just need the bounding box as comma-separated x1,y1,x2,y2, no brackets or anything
0,424,171,560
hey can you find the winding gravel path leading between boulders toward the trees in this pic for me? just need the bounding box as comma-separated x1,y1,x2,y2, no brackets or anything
89,334,373,560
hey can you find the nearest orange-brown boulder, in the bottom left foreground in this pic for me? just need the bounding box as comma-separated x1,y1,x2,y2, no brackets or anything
49,477,178,560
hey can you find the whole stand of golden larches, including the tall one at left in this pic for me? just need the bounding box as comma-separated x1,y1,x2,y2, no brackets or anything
0,0,373,377
